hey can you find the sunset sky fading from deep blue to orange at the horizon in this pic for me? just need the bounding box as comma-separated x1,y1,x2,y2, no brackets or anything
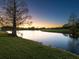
0,0,79,27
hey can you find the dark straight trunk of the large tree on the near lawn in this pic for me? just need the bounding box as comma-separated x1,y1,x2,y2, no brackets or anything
12,0,17,36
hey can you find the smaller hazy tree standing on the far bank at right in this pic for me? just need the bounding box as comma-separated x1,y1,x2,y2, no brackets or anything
68,14,78,35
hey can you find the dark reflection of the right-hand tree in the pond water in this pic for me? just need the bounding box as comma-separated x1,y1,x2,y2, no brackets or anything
63,34,79,54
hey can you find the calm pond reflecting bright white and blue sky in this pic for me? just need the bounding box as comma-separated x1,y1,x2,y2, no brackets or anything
8,30,79,54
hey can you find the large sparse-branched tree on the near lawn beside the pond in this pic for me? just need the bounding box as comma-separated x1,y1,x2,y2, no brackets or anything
2,0,28,36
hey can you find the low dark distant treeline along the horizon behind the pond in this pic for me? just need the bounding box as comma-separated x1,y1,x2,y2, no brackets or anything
1,25,79,30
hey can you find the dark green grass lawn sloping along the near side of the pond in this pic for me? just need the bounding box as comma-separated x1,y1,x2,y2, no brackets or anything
0,31,79,59
